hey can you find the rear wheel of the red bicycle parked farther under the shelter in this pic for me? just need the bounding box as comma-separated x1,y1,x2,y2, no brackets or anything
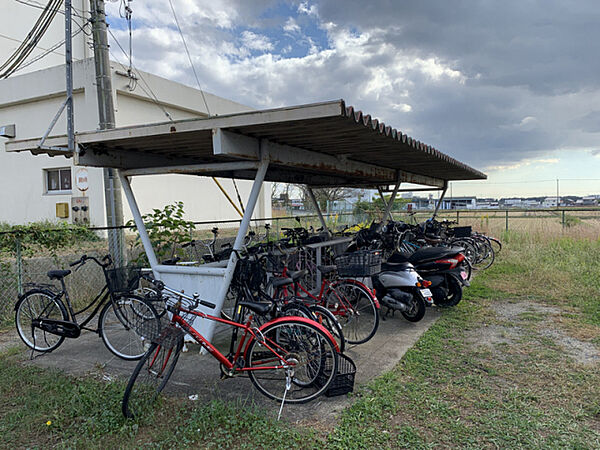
323,279,379,344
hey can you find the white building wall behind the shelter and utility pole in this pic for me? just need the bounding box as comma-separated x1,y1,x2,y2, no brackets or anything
0,59,271,226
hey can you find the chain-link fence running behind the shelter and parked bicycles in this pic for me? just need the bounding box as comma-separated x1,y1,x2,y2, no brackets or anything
0,208,600,324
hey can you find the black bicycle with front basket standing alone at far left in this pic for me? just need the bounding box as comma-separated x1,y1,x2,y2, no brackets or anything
15,255,160,360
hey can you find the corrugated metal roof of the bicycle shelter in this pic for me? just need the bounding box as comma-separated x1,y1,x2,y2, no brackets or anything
7,100,486,186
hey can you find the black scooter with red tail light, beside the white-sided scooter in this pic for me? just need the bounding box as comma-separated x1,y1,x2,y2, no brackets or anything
388,247,471,306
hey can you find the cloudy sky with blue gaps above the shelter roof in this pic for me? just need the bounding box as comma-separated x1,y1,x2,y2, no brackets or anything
107,0,600,197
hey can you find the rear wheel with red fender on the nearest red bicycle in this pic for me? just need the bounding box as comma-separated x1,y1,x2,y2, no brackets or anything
246,317,338,404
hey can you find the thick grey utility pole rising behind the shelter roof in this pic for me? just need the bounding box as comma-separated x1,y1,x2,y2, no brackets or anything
90,0,124,267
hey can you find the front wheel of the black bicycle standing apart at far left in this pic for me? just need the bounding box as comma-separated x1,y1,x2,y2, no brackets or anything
98,295,160,361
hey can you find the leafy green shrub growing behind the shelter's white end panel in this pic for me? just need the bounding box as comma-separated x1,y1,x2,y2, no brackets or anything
127,202,195,264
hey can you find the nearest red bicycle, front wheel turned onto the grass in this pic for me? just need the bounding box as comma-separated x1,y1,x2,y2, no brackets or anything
122,281,339,417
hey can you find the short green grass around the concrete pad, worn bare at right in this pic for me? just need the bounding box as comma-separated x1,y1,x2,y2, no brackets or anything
0,233,600,449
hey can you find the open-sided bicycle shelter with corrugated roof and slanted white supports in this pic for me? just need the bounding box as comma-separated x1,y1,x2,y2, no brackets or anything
6,100,486,340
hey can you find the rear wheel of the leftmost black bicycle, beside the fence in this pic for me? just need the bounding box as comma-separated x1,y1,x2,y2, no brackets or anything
15,289,69,353
